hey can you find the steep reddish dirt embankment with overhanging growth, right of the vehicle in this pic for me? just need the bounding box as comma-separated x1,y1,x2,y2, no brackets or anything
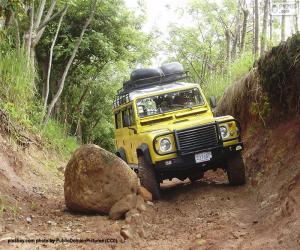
217,35,300,249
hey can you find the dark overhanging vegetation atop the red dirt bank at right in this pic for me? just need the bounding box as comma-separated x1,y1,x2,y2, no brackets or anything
258,34,300,113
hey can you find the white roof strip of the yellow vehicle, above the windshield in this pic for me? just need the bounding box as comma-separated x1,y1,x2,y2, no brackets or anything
129,82,198,101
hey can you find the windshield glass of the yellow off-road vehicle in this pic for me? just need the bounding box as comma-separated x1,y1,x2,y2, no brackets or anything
137,88,204,117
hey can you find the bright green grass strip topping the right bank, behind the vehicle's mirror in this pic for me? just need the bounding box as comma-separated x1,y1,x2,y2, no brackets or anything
202,53,254,99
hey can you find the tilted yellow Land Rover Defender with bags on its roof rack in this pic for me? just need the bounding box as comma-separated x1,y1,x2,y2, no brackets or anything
114,63,245,199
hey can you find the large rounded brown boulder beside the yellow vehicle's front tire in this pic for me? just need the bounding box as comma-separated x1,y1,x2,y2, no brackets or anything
64,145,138,214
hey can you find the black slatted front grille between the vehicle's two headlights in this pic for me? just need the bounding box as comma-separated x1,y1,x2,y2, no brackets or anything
176,124,219,155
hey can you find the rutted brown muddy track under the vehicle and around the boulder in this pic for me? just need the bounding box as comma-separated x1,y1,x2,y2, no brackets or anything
0,171,259,249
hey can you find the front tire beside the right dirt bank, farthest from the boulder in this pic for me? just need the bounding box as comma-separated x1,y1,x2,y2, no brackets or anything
227,152,246,186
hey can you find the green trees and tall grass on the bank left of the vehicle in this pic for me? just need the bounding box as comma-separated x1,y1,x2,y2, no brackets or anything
0,0,153,155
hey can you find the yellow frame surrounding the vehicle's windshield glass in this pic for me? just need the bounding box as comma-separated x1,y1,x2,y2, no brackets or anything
135,86,206,119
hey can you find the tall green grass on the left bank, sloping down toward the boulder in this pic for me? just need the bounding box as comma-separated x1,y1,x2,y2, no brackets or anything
0,44,78,156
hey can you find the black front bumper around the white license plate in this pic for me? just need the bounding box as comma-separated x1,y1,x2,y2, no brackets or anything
155,142,243,174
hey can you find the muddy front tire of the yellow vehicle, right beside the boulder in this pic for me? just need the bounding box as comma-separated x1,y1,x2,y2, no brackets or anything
138,155,160,200
